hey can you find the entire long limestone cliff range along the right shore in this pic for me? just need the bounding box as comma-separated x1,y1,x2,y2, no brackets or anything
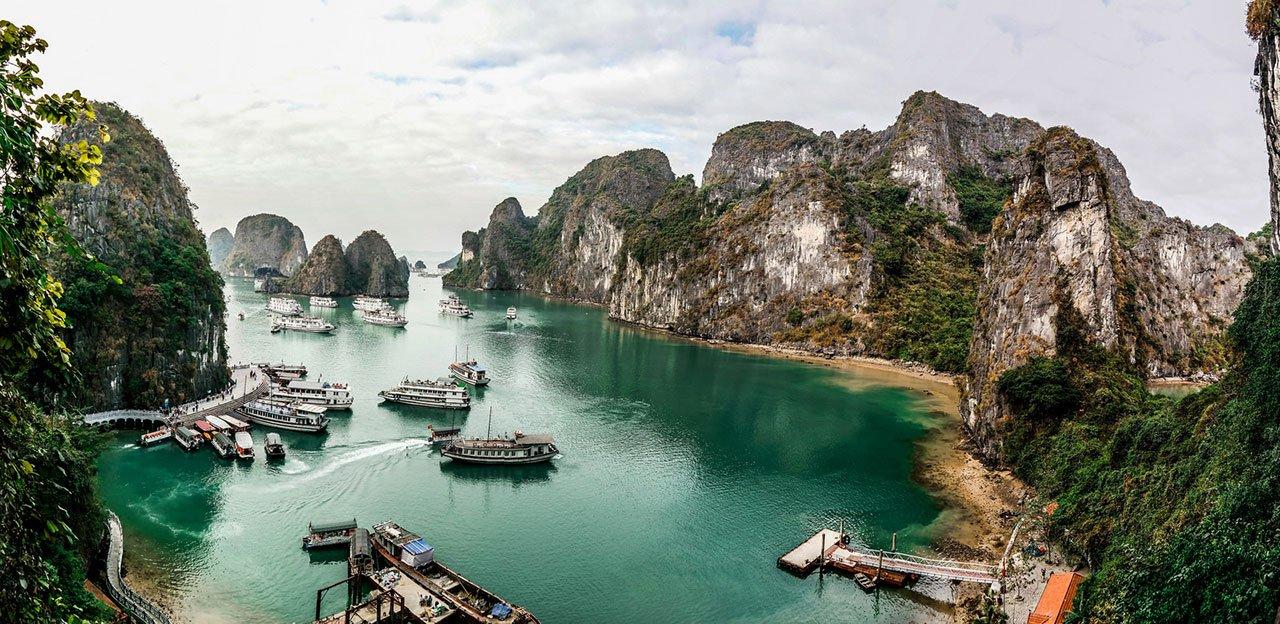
449,92,1248,462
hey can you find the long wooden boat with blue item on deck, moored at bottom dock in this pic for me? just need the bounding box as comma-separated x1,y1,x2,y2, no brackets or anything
370,520,539,624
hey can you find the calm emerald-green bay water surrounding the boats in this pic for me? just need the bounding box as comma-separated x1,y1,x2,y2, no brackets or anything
100,276,950,624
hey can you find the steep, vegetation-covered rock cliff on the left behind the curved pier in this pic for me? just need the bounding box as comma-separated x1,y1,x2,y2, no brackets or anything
56,104,228,409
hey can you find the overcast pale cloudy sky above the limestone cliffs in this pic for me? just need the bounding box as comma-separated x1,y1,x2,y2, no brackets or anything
10,0,1267,251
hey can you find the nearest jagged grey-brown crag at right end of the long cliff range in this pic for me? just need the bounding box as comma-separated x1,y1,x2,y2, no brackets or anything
961,128,1251,458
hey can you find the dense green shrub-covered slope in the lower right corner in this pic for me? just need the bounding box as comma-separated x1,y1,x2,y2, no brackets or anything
1000,265,1280,623
